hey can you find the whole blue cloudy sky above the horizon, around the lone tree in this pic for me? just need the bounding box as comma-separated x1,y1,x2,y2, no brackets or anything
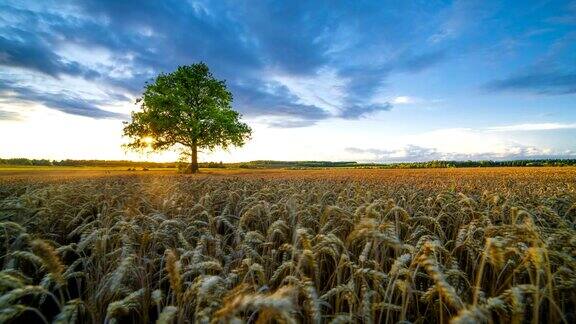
0,0,576,162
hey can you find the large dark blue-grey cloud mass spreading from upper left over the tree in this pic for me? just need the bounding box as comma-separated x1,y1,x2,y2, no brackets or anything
0,0,445,127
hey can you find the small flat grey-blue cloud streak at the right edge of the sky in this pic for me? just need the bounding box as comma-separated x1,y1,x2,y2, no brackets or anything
484,72,576,95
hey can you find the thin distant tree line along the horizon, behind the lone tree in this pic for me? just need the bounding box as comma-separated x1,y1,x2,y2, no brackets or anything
0,158,576,169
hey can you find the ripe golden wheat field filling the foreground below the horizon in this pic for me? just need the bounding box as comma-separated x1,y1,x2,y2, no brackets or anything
0,167,576,323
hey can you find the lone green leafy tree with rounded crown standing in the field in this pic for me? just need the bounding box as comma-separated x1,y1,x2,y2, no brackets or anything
124,63,252,173
